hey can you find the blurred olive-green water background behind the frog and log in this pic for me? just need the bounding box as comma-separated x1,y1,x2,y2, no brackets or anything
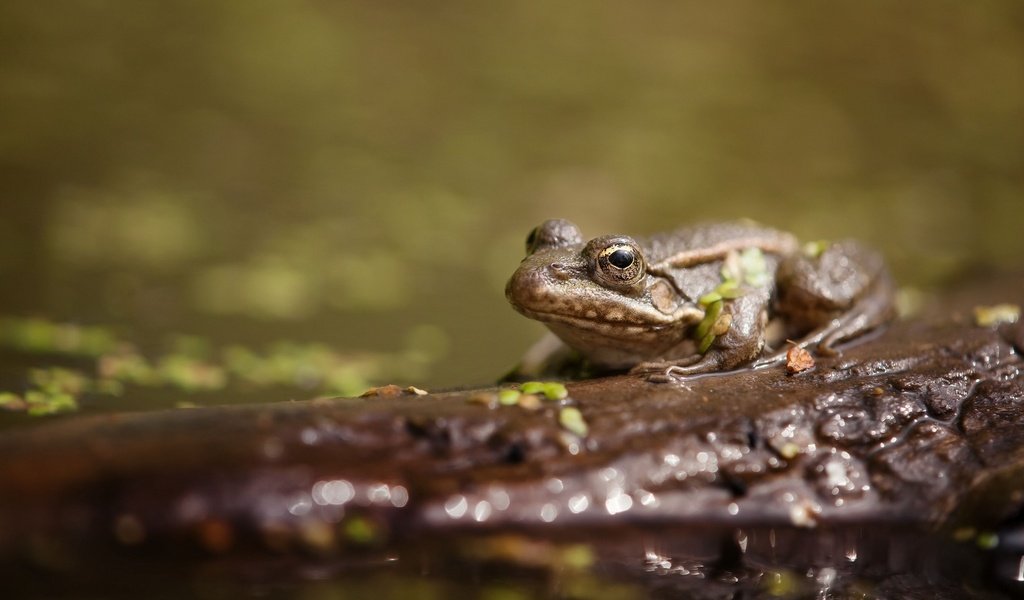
0,0,1024,401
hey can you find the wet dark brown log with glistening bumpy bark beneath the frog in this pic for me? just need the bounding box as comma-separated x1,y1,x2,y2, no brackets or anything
0,276,1024,593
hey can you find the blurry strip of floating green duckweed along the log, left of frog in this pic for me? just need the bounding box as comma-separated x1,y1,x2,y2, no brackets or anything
0,317,447,416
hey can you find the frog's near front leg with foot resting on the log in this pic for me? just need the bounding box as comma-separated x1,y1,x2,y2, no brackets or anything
630,288,771,382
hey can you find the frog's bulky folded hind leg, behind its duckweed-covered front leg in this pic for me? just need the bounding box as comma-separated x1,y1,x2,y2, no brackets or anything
756,242,895,367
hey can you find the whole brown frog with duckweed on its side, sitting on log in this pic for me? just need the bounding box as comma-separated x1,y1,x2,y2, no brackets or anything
505,219,895,381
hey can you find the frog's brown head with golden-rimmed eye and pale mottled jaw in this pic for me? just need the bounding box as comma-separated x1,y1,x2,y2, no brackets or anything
505,219,703,367
